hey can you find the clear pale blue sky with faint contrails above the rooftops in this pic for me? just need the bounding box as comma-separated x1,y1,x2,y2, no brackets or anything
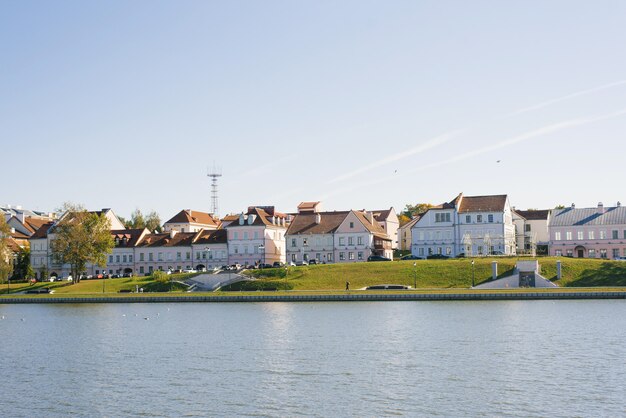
0,0,626,220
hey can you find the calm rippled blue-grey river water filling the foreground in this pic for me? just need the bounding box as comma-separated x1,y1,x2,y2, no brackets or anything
0,301,626,417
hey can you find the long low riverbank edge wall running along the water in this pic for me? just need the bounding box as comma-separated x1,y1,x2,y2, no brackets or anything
0,291,626,304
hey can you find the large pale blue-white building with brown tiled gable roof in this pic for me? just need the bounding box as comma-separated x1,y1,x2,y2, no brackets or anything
411,193,517,257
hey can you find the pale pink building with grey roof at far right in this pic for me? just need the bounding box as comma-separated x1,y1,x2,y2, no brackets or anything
548,202,626,259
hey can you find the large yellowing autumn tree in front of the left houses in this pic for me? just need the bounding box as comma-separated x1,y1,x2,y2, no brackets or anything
50,203,115,283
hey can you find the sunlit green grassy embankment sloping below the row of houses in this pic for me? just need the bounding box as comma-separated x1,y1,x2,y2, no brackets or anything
0,257,626,297
